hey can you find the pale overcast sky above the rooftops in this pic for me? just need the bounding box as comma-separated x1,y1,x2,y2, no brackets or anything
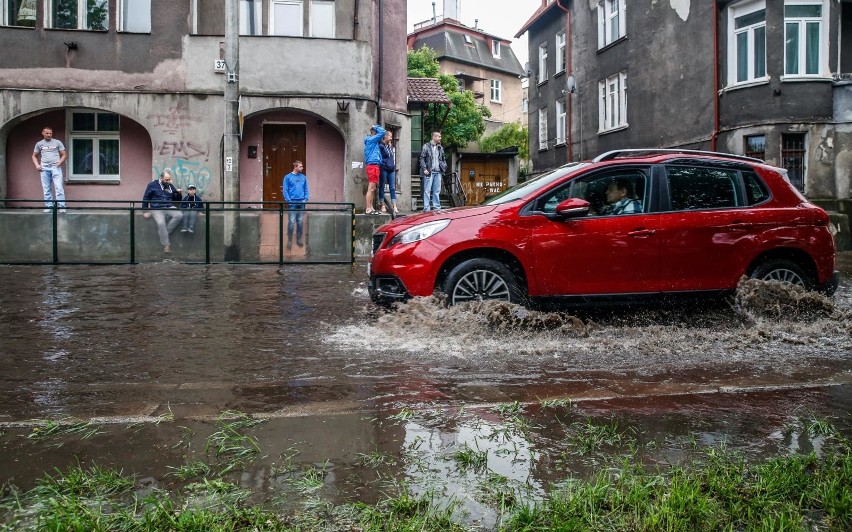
408,0,541,66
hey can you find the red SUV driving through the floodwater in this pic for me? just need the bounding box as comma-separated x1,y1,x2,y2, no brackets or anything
369,150,840,306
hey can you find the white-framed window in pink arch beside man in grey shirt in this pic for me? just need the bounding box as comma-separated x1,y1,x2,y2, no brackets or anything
68,111,120,181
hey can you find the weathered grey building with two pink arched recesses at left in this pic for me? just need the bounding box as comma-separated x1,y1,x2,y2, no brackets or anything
0,0,410,209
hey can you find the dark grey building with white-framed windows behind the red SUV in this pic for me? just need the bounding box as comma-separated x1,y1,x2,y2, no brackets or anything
516,0,852,199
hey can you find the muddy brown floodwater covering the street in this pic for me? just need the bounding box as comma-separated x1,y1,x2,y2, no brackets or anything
0,263,852,528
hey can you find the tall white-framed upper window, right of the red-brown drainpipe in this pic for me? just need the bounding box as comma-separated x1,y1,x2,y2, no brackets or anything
728,0,767,85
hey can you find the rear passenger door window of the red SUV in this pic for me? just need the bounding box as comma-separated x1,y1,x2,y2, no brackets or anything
666,166,743,211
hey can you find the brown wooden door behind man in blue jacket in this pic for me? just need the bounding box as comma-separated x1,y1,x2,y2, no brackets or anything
263,124,305,208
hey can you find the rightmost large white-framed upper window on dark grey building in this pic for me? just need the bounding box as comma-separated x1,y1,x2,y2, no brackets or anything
784,0,828,76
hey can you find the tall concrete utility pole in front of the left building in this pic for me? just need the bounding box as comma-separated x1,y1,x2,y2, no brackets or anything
223,0,240,261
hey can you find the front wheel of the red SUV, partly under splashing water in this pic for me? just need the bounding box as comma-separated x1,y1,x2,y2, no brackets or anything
443,259,526,305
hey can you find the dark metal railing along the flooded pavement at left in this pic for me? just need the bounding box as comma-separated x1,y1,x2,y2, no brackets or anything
0,199,355,265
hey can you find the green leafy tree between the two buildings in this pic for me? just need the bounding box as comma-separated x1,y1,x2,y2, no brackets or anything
408,45,491,149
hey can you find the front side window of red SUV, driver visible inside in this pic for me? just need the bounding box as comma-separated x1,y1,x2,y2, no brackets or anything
536,168,649,216
